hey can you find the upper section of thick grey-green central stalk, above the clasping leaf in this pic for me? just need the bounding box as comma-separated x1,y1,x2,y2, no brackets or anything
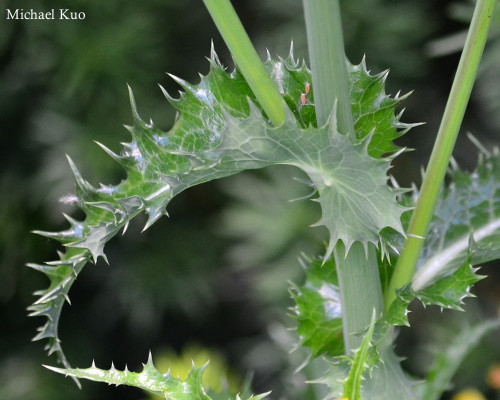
303,0,354,130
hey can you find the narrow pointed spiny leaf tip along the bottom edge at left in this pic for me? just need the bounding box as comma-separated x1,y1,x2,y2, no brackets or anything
45,354,268,400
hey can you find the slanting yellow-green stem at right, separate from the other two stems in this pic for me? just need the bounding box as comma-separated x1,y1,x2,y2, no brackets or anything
385,0,496,310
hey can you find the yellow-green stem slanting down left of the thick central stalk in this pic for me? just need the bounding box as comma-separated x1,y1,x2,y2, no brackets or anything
203,0,285,126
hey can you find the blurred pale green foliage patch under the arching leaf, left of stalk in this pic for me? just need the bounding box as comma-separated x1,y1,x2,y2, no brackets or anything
220,167,327,307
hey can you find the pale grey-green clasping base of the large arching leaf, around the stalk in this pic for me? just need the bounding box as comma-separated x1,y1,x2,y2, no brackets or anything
221,103,406,259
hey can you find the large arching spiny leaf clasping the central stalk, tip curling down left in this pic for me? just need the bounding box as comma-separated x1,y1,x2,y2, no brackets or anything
31,50,412,372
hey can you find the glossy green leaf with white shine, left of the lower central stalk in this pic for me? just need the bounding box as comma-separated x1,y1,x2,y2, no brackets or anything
291,256,344,357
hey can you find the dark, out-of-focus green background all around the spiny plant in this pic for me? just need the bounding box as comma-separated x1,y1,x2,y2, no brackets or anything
0,0,500,400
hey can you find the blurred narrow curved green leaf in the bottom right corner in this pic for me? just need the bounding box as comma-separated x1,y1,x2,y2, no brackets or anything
421,319,500,400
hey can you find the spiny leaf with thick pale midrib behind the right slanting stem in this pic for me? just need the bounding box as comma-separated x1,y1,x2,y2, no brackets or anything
386,147,500,325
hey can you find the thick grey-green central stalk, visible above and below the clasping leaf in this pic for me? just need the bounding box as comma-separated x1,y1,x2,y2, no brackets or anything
303,0,383,354
